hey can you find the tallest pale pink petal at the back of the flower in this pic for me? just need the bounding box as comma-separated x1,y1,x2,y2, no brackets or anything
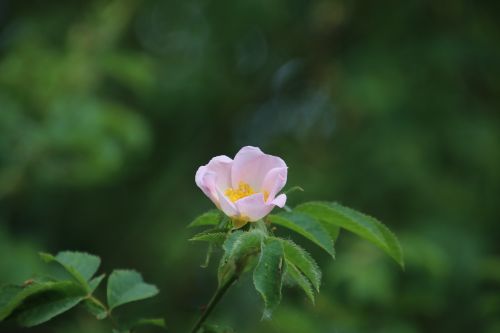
231,146,286,191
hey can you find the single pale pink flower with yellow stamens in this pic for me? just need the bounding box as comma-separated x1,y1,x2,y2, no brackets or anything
195,146,288,228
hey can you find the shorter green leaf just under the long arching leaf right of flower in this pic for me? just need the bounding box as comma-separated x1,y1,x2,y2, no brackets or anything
267,212,335,258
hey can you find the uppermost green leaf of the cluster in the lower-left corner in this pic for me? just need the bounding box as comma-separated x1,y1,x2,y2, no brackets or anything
40,251,101,291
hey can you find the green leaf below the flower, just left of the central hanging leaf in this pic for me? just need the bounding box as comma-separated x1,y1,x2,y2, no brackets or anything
218,229,265,286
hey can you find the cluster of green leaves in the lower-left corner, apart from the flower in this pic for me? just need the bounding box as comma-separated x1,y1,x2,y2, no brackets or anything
0,251,165,332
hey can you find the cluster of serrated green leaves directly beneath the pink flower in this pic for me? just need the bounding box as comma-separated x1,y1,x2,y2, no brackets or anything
191,202,403,319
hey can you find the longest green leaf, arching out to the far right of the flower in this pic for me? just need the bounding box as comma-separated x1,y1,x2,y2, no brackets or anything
295,202,404,267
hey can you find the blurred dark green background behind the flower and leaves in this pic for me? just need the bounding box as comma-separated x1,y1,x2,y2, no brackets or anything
0,0,500,333
